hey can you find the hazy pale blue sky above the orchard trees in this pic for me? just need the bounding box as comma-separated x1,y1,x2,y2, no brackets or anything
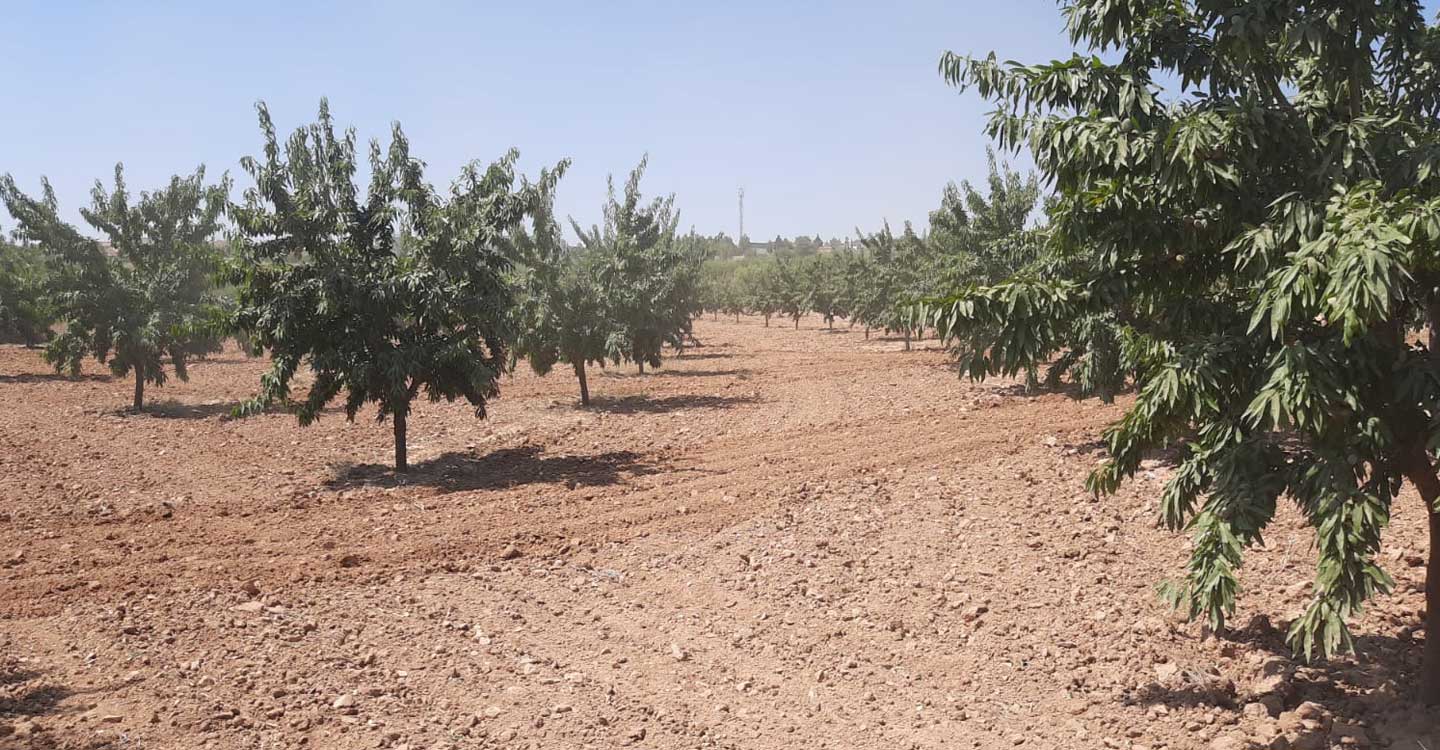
0,0,1070,240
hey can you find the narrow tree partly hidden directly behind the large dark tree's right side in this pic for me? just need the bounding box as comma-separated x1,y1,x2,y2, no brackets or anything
513,164,613,406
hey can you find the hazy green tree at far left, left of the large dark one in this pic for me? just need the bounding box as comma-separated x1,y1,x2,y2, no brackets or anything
0,164,229,412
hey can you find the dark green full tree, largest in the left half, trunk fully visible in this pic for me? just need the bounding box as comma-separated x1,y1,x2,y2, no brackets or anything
232,101,550,472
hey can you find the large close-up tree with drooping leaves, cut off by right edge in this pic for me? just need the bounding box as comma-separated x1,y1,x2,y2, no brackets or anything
940,0,1440,702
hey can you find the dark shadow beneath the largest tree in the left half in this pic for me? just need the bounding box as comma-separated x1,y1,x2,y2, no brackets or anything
325,445,661,492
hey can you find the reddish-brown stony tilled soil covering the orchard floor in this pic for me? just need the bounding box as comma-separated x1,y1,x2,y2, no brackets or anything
0,312,1440,750
